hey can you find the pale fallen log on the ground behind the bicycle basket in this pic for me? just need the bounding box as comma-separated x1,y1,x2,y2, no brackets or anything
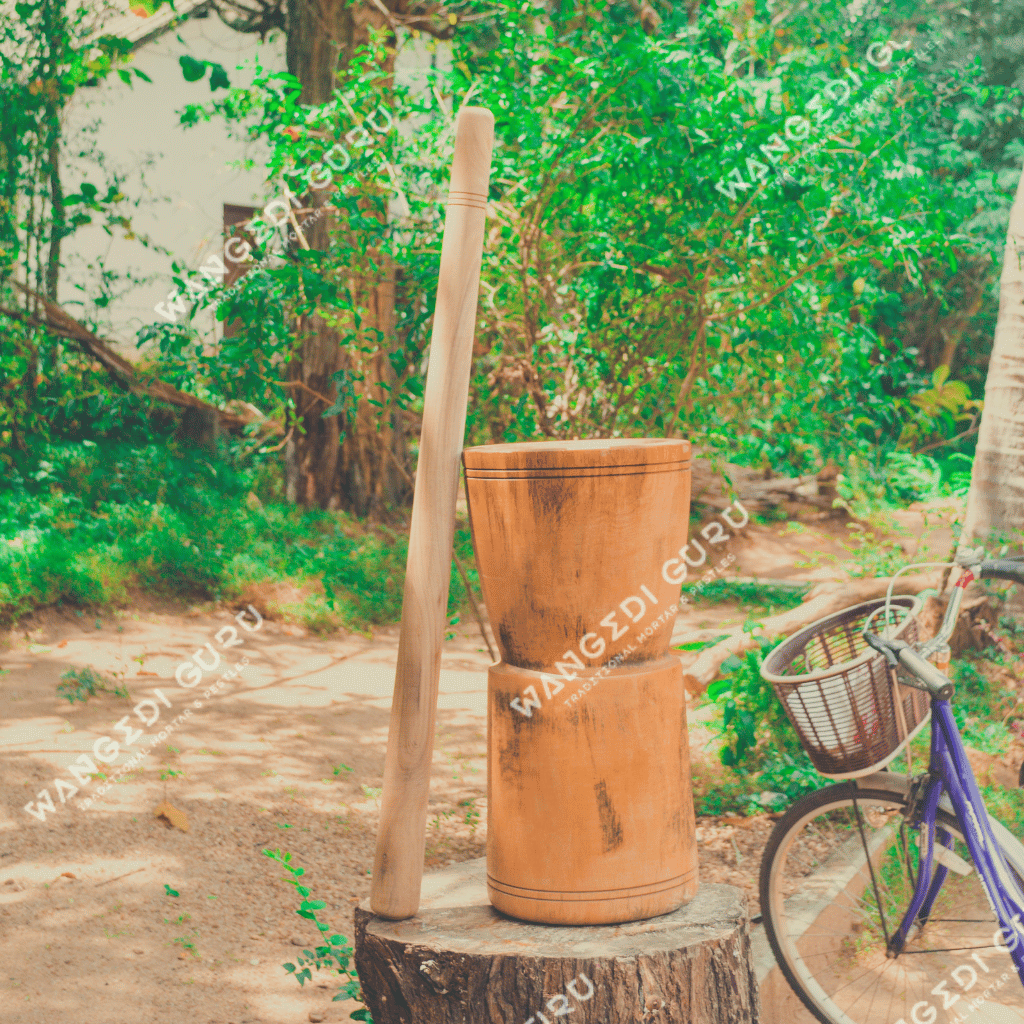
683,575,937,696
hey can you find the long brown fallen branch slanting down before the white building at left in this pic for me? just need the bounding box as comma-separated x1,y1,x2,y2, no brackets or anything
0,281,282,434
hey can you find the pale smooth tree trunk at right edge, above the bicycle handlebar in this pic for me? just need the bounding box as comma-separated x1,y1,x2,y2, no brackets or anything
962,161,1024,544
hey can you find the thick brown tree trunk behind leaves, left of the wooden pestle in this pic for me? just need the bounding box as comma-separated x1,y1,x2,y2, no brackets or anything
286,0,411,516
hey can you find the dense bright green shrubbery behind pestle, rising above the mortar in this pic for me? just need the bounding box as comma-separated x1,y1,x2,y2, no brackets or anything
140,0,1020,495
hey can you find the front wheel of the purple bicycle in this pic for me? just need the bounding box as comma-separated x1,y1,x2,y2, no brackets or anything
761,782,1024,1024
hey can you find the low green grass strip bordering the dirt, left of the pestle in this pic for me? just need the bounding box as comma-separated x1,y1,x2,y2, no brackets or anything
0,442,472,632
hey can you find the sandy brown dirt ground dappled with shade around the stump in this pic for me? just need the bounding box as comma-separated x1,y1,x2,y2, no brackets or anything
0,499,966,1024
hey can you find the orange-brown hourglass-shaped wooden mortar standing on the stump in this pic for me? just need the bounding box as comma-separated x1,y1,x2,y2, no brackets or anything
463,438,697,925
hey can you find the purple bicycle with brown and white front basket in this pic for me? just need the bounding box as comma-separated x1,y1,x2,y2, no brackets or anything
760,552,1024,1024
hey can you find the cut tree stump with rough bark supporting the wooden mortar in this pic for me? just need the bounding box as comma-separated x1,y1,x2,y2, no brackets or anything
355,851,760,1024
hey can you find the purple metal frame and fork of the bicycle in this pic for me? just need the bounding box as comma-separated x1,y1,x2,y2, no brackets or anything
890,699,1024,985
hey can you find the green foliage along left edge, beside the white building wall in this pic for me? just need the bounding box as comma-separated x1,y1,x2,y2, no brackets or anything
0,0,164,464
